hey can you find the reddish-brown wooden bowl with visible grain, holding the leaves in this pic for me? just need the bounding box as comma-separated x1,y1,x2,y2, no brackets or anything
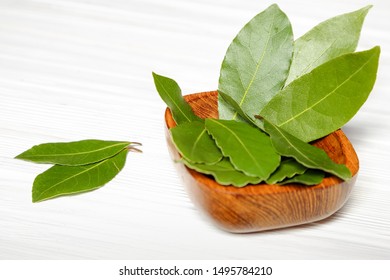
165,91,359,233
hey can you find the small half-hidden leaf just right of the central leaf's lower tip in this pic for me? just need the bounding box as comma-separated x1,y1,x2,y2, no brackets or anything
266,158,307,184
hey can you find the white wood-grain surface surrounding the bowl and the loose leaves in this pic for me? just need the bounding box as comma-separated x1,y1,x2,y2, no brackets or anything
0,0,390,259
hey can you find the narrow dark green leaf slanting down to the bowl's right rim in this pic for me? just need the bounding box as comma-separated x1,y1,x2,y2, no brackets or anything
264,120,352,180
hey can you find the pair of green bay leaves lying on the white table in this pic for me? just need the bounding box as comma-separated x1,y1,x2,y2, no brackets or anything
16,140,139,202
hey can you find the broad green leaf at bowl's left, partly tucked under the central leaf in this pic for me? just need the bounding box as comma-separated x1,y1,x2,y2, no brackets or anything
170,121,223,164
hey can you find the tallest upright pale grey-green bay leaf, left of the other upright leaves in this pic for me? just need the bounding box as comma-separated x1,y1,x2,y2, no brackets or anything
218,4,293,119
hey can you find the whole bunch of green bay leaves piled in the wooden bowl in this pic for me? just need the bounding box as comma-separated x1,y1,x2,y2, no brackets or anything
153,4,380,187
